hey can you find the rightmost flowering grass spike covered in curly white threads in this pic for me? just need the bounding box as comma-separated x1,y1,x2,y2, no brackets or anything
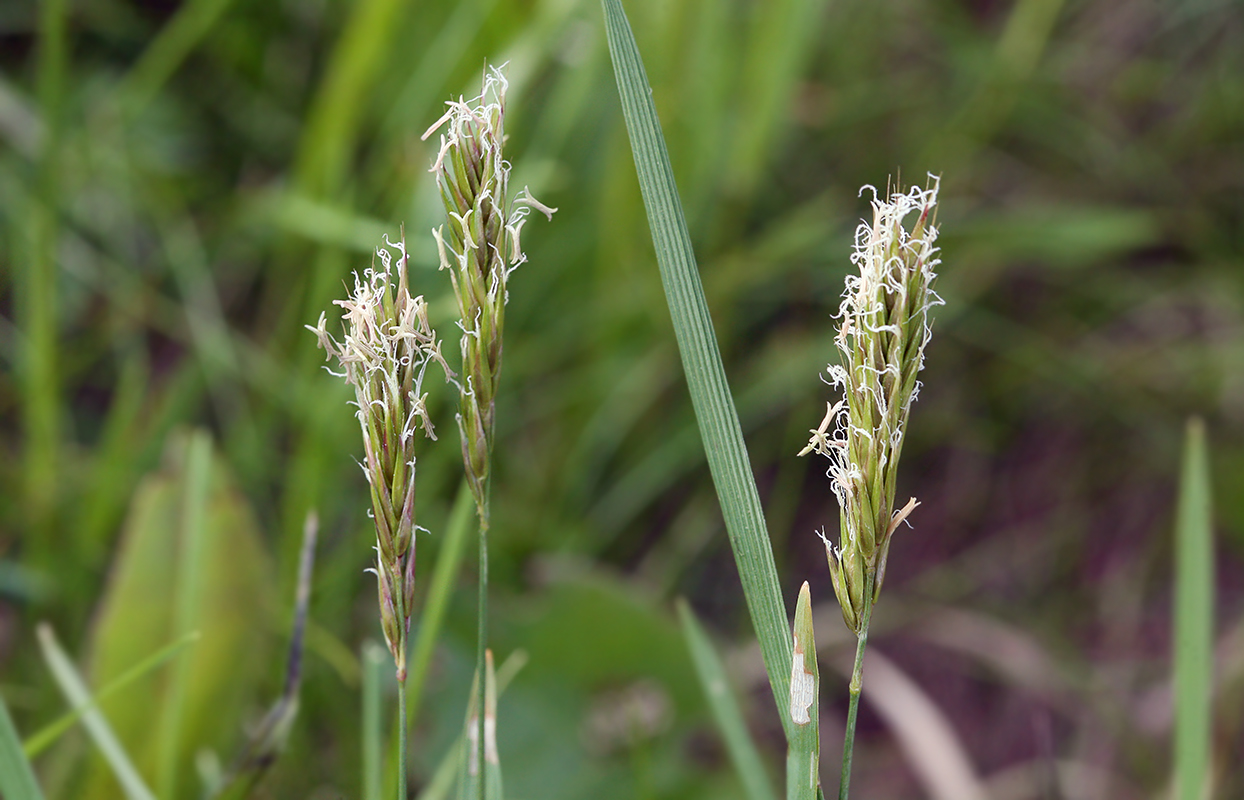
800,177,942,633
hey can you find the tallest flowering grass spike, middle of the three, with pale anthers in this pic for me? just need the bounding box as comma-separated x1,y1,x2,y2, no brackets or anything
423,68,556,510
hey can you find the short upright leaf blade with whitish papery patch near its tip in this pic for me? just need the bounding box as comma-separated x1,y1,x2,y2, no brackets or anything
786,581,821,800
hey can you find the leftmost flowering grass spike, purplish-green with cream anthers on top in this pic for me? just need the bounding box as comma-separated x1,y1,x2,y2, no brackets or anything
307,236,449,681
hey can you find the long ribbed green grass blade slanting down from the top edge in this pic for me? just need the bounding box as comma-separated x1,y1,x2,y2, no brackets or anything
602,0,791,738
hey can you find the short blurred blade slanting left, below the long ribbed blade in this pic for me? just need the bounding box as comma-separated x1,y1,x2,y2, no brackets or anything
678,598,778,800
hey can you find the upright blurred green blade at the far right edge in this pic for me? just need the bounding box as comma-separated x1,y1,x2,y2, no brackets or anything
1174,419,1214,800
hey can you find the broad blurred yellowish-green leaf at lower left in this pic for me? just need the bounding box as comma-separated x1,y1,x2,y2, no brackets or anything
81,433,277,800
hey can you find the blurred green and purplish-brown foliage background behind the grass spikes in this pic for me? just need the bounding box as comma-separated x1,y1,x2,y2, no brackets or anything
0,0,1244,800
